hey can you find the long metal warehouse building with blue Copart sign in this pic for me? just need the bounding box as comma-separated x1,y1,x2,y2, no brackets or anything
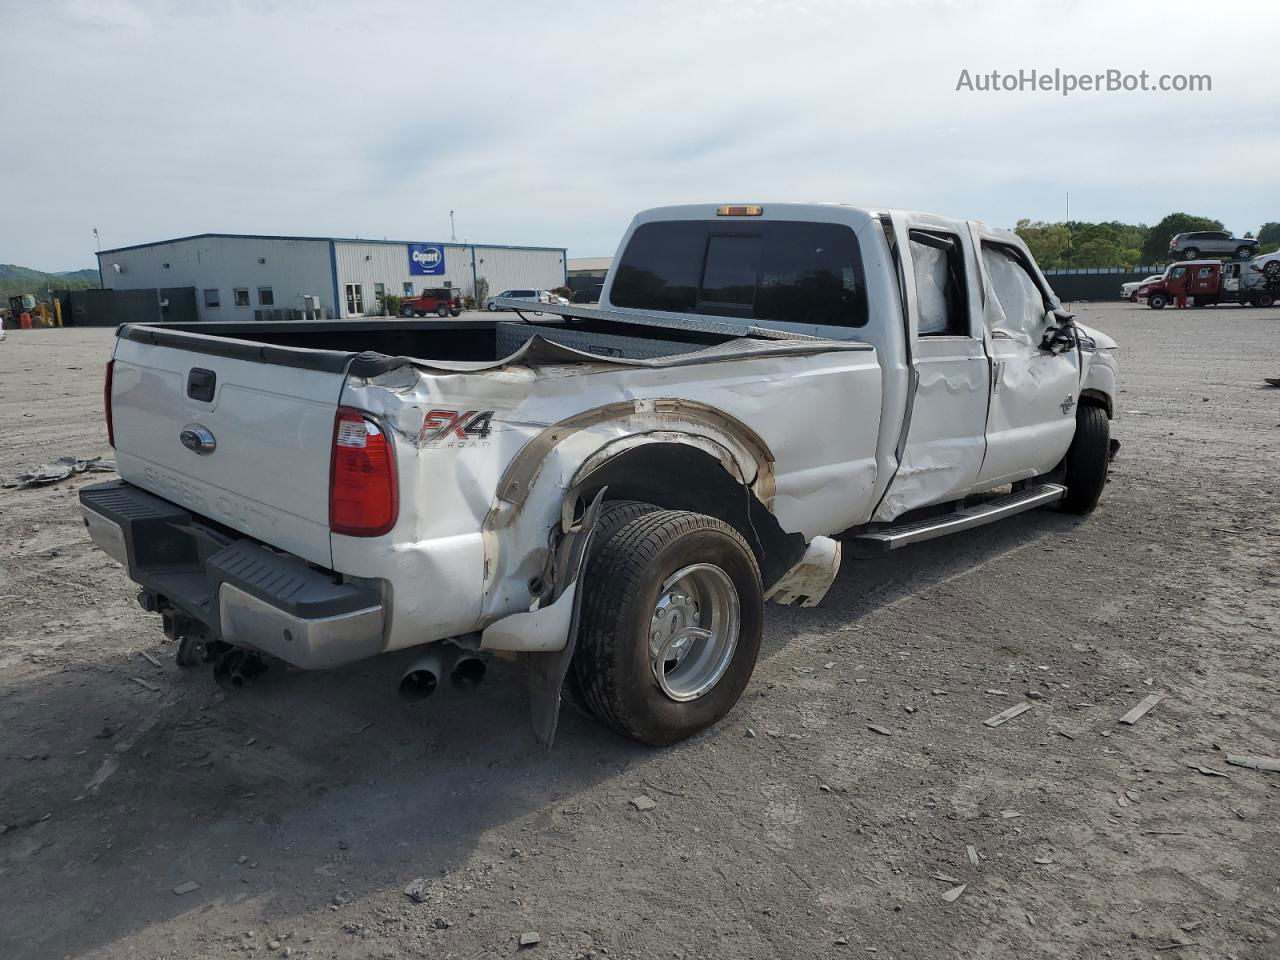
97,233,567,320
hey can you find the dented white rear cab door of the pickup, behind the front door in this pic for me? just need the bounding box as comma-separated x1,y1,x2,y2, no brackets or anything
874,216,991,521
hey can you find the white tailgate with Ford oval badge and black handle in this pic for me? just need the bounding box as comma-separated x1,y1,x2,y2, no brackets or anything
111,337,346,567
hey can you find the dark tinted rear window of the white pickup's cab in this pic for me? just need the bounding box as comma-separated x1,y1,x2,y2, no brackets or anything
609,220,867,326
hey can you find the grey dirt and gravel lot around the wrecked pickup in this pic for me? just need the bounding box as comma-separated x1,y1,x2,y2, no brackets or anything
0,305,1280,960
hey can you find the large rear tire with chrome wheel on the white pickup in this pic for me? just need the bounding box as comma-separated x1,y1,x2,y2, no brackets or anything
572,504,764,746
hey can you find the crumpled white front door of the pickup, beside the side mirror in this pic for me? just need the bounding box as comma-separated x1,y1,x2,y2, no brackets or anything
978,239,1080,485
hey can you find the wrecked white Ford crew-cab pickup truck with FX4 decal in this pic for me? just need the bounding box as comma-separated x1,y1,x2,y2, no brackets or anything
81,204,1116,744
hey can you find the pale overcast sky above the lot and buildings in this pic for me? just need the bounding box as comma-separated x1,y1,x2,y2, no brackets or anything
0,0,1280,270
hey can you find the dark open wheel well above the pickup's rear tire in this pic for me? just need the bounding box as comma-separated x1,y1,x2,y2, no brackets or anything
579,443,805,590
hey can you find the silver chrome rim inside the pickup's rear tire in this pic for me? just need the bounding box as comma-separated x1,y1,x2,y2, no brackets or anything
649,563,741,701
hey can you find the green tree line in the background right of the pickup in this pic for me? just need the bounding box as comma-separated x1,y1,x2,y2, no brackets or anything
1014,214,1280,270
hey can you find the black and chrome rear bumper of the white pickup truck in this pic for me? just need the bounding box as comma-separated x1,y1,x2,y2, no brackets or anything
79,480,387,669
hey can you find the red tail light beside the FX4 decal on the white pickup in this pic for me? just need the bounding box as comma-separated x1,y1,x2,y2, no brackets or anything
329,407,399,536
